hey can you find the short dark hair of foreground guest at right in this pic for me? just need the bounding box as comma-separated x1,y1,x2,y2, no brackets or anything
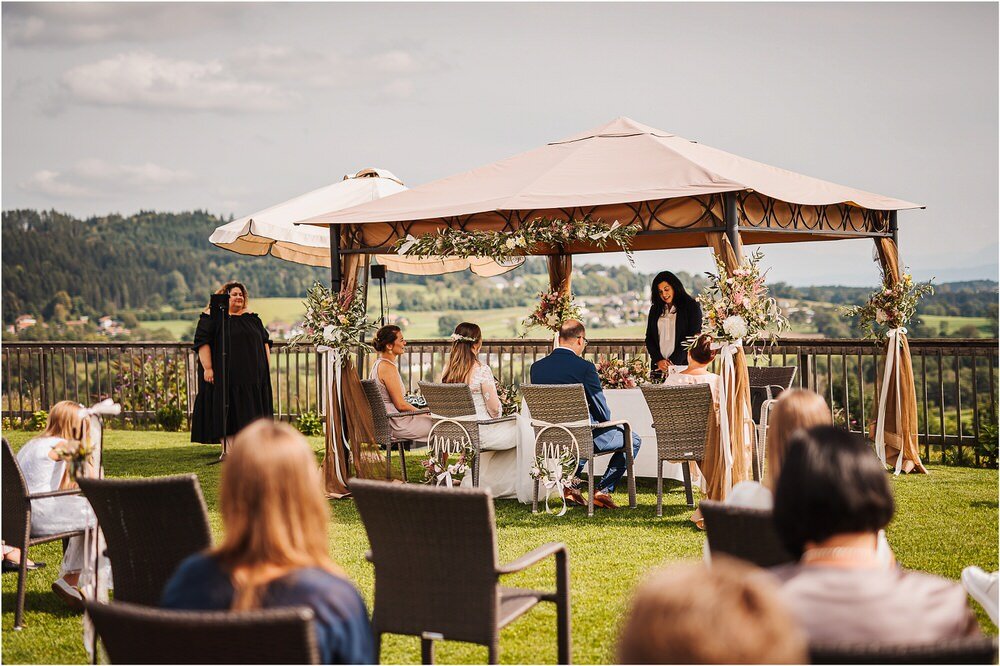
774,425,895,556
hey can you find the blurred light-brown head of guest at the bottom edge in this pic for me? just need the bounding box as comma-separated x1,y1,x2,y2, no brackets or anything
618,557,807,664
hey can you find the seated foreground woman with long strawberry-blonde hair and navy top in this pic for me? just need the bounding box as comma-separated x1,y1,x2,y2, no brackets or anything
160,419,375,664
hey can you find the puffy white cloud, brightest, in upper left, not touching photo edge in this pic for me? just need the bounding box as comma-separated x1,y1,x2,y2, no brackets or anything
62,51,295,111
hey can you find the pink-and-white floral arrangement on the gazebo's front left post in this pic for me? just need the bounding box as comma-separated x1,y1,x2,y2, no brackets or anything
295,282,375,352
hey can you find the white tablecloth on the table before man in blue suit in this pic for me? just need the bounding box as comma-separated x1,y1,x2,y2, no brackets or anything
517,389,684,503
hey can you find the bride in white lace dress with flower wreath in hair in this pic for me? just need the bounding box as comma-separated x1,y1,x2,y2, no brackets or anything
441,322,518,497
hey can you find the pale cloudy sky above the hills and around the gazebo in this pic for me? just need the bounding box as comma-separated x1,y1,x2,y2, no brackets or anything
0,2,998,285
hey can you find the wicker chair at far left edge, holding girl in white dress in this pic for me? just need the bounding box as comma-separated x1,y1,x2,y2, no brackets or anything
2,438,83,630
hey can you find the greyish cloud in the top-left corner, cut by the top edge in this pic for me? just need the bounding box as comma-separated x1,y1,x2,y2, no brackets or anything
3,2,246,48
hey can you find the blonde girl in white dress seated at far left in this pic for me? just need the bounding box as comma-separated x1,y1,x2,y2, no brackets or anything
17,400,110,608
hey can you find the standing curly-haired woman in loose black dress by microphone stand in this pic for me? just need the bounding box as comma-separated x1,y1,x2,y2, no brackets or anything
191,282,274,458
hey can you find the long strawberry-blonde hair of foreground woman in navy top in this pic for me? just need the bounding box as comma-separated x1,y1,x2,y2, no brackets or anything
214,419,335,608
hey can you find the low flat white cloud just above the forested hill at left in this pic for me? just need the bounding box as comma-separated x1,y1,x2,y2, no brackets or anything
18,159,194,199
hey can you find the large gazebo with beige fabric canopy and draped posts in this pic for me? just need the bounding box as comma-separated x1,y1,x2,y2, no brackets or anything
299,118,923,492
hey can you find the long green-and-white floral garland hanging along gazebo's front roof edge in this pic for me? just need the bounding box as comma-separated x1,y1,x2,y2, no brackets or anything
395,218,639,264
